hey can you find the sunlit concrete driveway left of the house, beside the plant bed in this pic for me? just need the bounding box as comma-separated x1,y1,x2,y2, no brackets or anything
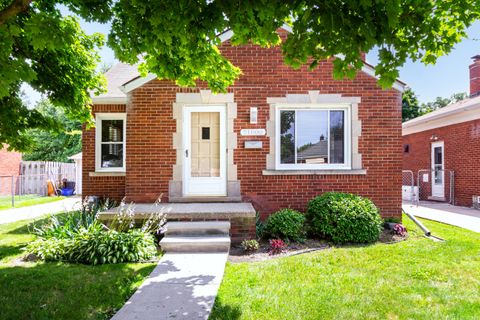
0,197,82,224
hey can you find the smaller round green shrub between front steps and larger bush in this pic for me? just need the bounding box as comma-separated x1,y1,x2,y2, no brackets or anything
263,209,305,242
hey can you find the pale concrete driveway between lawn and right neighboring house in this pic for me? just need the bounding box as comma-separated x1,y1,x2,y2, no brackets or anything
402,201,480,232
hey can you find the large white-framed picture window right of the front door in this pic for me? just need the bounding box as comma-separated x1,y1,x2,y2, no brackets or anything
277,107,350,169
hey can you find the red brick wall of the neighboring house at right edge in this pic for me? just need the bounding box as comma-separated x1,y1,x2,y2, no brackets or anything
403,120,480,207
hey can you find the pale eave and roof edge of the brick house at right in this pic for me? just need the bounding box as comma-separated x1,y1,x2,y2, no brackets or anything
402,96,480,136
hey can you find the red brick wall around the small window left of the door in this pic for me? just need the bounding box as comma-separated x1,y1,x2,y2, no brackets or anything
82,104,125,201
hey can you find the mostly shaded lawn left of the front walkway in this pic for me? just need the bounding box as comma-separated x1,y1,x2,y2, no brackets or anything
0,214,155,319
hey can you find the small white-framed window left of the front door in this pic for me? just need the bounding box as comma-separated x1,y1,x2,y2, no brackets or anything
95,113,126,171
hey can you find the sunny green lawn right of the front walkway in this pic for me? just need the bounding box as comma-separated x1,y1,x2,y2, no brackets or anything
210,218,480,320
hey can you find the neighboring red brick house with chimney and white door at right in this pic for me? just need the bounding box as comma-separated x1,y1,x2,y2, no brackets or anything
403,55,480,207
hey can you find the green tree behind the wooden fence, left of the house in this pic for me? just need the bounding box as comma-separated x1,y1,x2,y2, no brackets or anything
23,100,82,162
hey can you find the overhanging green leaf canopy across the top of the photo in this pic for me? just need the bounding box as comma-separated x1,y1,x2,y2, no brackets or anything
0,0,480,149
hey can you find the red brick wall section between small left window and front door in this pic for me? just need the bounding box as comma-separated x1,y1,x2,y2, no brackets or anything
125,85,179,202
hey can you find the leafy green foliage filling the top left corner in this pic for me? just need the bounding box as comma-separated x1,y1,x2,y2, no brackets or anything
0,0,106,151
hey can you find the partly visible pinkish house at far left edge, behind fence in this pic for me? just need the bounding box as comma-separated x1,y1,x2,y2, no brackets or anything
0,145,22,195
